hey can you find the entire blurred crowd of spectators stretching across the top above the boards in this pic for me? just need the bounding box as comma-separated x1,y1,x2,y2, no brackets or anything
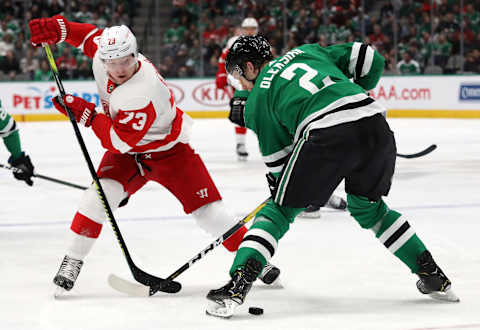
0,0,480,80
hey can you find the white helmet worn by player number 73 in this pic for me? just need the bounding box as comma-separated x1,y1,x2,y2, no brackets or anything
98,25,138,60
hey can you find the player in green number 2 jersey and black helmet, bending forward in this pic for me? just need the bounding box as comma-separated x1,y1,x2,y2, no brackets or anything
207,36,459,317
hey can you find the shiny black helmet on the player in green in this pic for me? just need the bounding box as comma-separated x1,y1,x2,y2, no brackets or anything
225,35,273,75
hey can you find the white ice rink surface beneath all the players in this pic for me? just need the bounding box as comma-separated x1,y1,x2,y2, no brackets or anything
0,119,480,330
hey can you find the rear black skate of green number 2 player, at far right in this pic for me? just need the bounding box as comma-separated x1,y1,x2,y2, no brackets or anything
417,251,460,302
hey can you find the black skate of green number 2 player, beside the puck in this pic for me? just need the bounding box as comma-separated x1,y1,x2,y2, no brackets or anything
206,258,262,318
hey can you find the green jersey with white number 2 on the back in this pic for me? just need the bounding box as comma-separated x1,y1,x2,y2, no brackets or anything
244,42,386,174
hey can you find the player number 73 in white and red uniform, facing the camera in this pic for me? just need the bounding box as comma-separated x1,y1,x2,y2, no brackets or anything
29,15,279,292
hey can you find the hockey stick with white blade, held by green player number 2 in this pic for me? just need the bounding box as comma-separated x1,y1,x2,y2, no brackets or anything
108,197,270,297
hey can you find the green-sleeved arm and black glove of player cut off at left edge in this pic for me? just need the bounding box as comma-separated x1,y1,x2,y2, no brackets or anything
0,101,33,186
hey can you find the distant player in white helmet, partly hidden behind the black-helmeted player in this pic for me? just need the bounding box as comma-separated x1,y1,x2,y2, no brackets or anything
215,17,258,161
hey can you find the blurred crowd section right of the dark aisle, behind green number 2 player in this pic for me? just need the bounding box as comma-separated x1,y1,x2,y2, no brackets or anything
160,0,480,77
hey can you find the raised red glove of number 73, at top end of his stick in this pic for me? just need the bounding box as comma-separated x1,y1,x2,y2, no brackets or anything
28,15,69,46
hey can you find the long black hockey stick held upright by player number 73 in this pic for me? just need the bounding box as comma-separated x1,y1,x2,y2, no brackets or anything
43,44,182,293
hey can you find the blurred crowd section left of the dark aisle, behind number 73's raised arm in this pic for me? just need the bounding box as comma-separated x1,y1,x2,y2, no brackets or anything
0,0,135,81
